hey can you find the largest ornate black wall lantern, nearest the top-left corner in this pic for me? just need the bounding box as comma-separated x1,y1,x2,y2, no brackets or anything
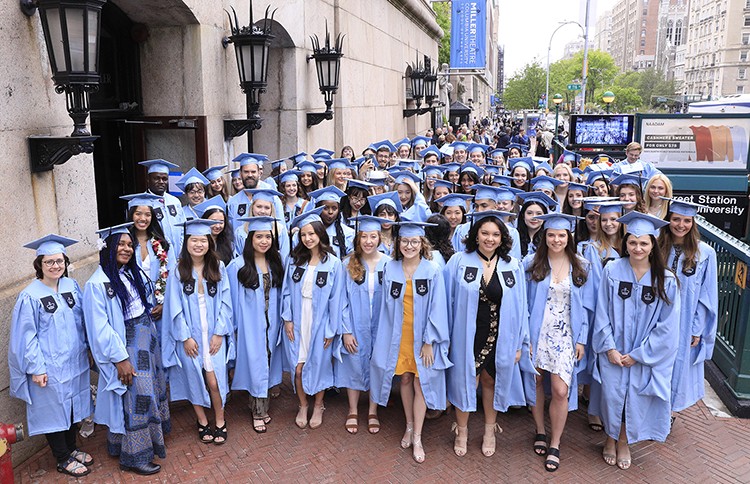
20,0,106,173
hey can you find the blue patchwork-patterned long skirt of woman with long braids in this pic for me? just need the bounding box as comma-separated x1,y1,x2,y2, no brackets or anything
107,312,172,467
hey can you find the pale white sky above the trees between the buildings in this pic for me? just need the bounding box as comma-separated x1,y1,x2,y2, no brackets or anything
499,0,617,79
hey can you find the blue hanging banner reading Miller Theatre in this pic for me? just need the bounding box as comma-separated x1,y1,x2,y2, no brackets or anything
451,0,487,69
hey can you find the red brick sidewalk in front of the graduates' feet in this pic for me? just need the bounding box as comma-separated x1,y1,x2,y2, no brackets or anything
15,379,750,484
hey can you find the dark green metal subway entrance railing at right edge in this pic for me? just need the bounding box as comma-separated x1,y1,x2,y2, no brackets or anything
695,216,750,399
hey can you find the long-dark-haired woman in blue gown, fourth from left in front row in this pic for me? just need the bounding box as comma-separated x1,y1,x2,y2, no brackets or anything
227,217,286,433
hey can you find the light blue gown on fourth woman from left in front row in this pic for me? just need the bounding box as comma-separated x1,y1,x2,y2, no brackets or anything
227,256,284,398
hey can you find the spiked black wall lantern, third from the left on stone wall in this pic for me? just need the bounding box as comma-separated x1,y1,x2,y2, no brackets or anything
307,22,345,128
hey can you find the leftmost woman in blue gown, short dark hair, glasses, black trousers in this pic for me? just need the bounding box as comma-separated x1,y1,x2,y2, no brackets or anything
8,234,93,477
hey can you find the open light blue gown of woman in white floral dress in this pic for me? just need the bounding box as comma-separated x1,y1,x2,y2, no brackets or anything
523,255,596,411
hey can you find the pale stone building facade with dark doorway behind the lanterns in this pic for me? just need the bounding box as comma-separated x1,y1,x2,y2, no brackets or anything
0,0,443,462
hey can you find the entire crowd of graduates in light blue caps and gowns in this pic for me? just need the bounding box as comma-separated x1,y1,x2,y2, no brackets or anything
8,118,718,477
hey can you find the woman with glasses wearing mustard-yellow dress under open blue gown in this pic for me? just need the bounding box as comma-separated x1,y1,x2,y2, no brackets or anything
370,222,451,463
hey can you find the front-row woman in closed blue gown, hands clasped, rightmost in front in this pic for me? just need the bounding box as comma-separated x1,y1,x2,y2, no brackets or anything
590,212,680,469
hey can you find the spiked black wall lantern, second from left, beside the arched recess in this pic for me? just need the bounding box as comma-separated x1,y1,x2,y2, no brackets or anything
222,0,276,153
